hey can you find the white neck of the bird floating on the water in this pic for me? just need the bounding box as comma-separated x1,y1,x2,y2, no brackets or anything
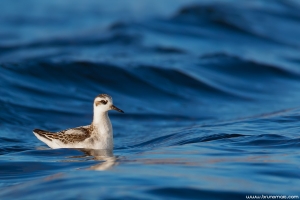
92,112,113,137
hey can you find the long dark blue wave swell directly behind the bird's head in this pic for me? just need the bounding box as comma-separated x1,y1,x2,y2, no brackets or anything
0,53,299,126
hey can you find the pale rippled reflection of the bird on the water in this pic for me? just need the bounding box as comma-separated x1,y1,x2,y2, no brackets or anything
78,149,118,171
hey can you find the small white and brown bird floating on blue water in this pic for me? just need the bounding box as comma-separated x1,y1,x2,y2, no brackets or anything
33,94,124,150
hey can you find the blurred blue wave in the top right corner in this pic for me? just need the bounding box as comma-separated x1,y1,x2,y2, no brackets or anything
172,2,300,47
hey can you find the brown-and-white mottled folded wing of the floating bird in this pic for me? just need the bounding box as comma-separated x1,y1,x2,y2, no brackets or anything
33,126,91,144
